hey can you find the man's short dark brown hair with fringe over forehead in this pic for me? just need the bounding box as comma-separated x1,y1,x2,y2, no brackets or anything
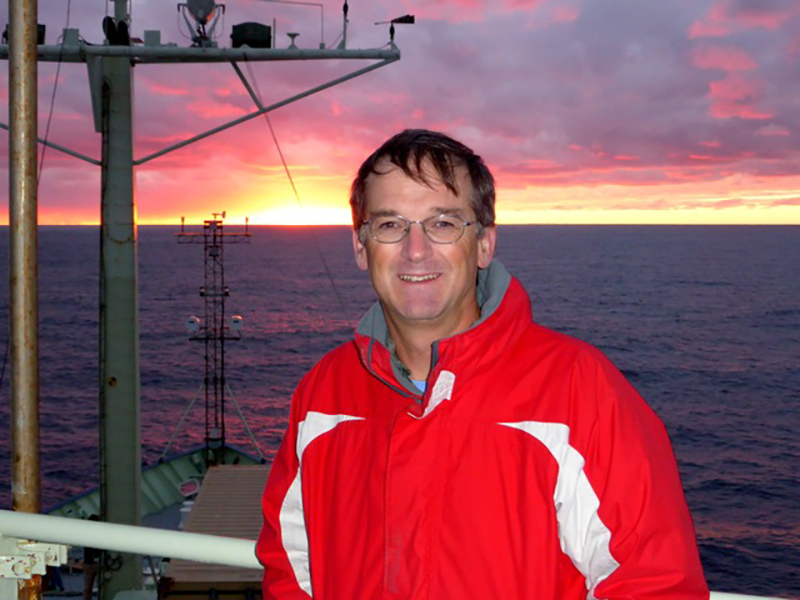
350,129,495,231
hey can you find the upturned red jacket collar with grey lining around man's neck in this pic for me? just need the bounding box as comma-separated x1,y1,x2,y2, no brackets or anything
356,260,531,400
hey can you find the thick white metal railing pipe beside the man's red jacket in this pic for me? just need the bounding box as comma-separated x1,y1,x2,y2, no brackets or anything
0,510,778,600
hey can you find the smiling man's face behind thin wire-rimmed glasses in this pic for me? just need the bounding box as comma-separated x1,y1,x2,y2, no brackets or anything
353,163,496,339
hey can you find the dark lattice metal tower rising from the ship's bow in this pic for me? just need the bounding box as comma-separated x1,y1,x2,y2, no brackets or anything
177,212,251,465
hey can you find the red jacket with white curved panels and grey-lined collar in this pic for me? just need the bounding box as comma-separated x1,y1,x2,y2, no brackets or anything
257,262,708,600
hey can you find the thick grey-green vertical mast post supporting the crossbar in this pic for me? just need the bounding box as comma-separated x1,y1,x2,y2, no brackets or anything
99,0,142,600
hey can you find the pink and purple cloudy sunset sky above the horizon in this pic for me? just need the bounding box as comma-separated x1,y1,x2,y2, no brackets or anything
0,0,800,224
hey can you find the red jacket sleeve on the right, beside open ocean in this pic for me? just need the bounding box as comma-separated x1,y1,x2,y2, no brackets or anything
582,355,709,600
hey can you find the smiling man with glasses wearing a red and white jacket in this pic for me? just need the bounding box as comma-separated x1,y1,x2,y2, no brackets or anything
257,130,708,600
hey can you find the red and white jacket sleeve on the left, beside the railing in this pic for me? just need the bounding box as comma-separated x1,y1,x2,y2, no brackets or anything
256,394,311,600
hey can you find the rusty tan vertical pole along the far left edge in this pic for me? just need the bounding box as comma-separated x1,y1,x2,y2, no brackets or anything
8,0,41,599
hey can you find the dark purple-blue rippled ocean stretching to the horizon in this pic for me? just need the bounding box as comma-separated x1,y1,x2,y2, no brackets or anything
0,225,800,597
